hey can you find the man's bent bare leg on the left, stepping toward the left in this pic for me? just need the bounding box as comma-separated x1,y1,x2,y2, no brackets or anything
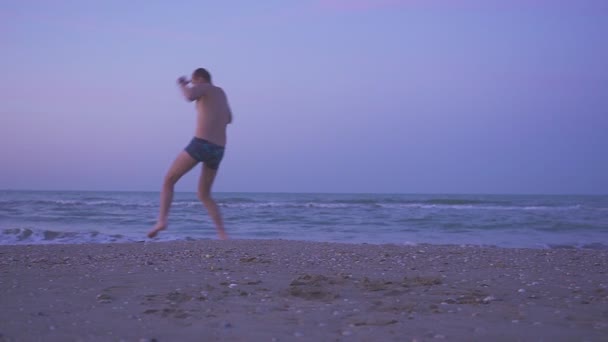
148,151,198,238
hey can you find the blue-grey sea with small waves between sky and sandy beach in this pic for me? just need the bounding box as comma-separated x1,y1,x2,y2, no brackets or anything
0,191,608,249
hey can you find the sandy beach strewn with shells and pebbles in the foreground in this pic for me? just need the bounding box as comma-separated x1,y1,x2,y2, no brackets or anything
0,240,608,341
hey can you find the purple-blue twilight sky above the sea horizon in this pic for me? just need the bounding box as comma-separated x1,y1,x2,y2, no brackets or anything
0,0,608,194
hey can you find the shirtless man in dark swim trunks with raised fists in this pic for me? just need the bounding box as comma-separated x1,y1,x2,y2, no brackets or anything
148,68,232,240
